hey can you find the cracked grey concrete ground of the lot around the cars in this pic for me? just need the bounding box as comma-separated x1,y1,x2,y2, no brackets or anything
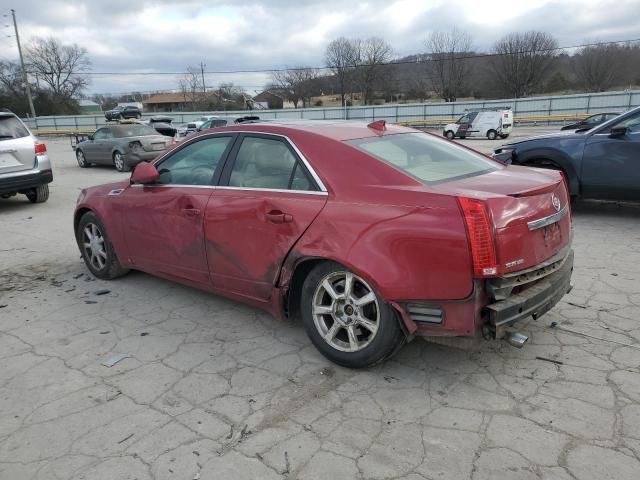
0,129,640,480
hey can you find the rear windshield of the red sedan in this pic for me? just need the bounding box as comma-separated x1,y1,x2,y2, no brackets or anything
347,133,499,183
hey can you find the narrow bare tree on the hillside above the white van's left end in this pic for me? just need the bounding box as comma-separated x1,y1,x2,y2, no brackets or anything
425,28,472,102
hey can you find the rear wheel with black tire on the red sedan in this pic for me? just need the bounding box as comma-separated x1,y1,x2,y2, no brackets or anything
300,262,405,368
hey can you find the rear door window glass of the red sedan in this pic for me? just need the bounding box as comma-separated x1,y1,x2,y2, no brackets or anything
229,137,315,190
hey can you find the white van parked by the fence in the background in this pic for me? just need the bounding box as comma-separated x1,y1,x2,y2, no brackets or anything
442,109,513,140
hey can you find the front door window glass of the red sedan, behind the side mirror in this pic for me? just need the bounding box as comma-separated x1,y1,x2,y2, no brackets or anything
158,137,231,185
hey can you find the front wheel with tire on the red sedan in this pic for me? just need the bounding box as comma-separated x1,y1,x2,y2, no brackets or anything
76,212,129,280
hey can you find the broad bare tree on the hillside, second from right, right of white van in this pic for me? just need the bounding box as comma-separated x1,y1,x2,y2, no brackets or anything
489,31,558,98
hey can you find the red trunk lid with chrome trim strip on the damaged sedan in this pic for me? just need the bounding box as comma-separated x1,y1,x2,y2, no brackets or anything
436,166,571,275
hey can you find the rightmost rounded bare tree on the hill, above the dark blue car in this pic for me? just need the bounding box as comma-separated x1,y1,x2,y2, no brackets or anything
573,44,623,92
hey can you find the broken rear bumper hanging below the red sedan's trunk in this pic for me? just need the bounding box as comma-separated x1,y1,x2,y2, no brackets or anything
485,250,573,338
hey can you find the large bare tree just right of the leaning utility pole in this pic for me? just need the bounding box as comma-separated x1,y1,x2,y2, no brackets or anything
26,37,91,100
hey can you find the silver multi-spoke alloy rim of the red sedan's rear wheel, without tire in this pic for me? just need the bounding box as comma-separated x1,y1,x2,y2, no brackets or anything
312,271,380,352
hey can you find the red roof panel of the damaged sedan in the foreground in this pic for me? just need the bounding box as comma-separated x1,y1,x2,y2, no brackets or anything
210,119,416,141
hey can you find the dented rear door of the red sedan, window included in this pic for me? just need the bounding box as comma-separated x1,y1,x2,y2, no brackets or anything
204,134,327,301
